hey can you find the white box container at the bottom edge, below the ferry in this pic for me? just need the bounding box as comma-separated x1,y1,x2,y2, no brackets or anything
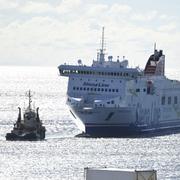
84,168,157,180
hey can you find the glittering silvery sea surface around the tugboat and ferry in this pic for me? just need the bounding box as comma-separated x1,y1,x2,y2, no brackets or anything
0,67,180,180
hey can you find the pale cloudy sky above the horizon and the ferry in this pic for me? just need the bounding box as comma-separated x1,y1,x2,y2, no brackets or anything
0,0,180,68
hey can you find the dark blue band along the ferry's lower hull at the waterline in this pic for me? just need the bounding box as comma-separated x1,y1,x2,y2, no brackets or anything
85,122,180,137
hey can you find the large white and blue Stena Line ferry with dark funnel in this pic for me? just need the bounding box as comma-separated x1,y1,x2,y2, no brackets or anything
58,28,180,137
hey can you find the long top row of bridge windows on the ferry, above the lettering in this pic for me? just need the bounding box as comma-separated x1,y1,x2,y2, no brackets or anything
62,70,134,77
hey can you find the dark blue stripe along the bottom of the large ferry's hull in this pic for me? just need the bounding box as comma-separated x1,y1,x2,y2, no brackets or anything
85,124,180,137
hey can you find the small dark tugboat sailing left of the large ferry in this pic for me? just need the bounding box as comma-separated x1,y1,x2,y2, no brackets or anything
6,90,46,141
